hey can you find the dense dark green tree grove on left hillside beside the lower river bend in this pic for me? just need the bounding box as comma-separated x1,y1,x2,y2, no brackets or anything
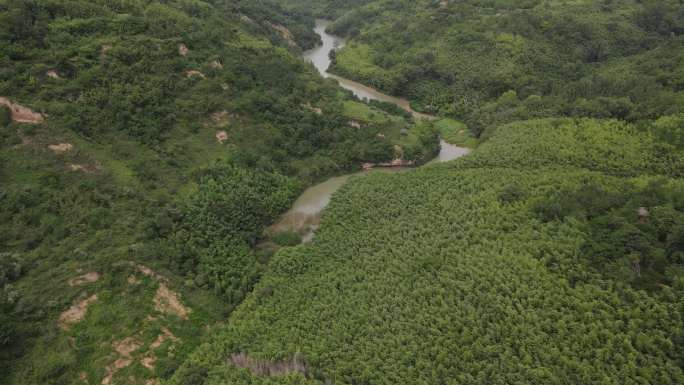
160,166,299,305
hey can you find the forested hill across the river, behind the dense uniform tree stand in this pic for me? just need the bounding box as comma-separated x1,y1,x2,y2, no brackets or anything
322,0,684,136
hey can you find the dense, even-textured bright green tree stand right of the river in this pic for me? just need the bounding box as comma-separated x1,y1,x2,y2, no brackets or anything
171,120,684,384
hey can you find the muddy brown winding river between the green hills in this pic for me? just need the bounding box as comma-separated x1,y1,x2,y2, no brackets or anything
268,20,470,242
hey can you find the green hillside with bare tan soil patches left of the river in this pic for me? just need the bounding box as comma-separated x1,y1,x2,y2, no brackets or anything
0,0,438,384
